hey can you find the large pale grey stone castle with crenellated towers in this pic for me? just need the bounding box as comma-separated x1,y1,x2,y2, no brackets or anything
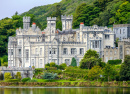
8,15,115,68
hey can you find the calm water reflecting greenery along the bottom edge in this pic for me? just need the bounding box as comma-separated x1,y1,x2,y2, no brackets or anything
0,87,130,94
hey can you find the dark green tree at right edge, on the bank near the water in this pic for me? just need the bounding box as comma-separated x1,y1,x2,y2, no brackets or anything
120,55,130,81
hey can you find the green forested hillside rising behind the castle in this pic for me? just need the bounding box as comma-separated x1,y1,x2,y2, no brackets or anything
0,0,130,57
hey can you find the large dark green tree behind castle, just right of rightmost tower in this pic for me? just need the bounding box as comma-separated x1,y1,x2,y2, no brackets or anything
73,3,100,28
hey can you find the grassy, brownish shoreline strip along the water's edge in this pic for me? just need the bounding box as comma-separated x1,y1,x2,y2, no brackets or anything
0,81,130,88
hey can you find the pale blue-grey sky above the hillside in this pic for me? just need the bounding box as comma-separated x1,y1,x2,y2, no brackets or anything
0,0,61,20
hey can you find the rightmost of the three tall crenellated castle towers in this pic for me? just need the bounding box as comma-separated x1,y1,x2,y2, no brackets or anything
61,15,73,31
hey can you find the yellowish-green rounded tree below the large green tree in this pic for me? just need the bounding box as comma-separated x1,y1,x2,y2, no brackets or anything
88,66,102,80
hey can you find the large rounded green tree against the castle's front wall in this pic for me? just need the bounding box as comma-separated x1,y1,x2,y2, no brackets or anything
80,49,101,69
